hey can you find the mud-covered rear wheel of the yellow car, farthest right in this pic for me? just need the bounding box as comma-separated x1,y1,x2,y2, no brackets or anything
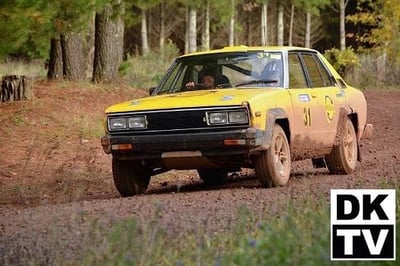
325,119,358,174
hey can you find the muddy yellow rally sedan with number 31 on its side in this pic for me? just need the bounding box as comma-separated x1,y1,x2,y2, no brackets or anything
101,46,372,196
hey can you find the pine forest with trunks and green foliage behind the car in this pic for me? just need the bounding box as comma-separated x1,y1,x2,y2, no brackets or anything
0,0,400,87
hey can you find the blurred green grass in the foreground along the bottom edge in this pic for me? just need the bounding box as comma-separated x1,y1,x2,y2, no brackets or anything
83,186,400,266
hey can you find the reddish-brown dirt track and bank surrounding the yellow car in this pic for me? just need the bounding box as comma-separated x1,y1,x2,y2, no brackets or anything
0,82,400,262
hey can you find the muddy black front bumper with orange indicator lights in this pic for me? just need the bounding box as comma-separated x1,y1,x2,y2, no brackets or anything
101,128,270,159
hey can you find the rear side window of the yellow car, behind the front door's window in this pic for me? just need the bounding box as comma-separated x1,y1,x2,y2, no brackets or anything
302,53,332,88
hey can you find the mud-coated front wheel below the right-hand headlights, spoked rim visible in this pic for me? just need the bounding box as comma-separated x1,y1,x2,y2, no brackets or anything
254,125,291,187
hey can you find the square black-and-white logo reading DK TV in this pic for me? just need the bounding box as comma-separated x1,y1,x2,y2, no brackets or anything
331,189,396,260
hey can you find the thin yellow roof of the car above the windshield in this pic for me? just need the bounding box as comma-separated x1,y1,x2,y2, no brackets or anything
180,45,317,58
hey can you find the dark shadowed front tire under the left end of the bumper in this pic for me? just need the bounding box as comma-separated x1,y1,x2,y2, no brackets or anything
112,158,151,197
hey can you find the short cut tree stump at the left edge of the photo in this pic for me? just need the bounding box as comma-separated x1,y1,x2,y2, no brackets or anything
0,75,33,102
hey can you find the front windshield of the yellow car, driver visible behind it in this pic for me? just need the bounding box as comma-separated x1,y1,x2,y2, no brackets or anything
156,51,283,94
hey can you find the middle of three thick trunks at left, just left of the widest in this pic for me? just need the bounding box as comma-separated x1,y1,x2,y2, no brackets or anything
61,33,86,81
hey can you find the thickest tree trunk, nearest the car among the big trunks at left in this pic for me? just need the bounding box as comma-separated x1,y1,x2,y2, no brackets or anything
93,1,124,83
